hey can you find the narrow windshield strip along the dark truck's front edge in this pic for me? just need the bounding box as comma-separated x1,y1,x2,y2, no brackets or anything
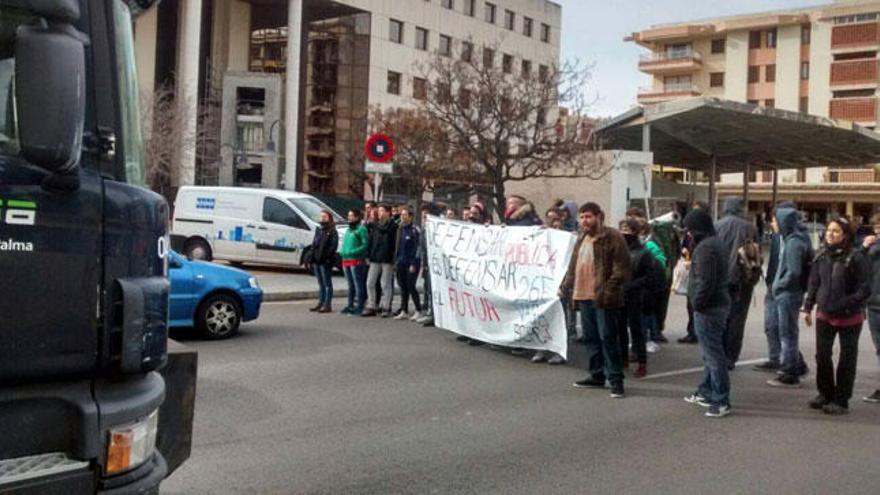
113,0,144,186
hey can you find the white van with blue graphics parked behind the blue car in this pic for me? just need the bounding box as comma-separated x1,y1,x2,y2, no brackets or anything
171,186,347,266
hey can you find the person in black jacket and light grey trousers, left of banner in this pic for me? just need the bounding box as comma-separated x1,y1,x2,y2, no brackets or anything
361,204,397,318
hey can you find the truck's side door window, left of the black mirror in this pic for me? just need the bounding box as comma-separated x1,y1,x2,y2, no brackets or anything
0,2,33,155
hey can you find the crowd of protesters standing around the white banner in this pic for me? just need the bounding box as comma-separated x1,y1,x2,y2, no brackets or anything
310,196,880,418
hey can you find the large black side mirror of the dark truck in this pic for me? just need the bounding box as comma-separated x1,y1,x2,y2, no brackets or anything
15,21,86,174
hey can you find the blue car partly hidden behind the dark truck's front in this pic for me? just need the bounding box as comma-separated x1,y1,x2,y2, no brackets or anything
168,251,263,340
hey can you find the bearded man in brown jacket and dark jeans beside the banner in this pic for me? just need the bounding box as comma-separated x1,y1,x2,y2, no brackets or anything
559,203,630,398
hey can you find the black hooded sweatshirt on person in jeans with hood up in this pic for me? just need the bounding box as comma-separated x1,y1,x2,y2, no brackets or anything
684,208,730,312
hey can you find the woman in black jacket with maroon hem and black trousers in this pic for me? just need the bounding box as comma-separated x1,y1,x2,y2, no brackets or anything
802,217,871,415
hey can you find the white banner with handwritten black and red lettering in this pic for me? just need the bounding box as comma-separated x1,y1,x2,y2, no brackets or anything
425,216,575,358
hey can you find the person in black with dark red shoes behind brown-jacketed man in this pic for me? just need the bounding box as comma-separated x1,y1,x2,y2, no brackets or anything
618,218,665,378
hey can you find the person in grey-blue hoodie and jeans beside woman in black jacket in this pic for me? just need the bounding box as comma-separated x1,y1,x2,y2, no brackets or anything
767,206,813,388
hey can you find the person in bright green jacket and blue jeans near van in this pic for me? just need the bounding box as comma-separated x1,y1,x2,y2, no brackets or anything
340,209,370,316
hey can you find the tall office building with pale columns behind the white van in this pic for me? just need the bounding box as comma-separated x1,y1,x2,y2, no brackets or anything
135,0,561,202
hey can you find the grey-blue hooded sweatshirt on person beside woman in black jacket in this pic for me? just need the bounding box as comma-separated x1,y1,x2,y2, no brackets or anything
771,207,813,297
